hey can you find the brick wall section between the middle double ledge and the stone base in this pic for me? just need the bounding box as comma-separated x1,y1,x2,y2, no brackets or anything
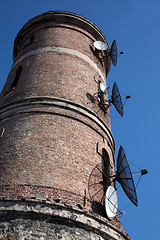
0,107,113,208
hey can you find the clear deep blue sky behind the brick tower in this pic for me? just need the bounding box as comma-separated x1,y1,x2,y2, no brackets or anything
0,0,160,240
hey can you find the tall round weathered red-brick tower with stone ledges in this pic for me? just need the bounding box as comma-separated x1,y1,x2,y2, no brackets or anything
0,11,130,240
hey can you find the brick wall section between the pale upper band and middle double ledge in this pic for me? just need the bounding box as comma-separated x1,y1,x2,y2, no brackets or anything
1,52,109,122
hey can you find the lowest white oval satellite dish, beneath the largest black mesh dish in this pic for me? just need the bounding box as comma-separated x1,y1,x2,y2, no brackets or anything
105,186,118,219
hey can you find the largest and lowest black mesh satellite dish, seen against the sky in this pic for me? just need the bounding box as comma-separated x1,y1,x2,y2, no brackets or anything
115,146,138,206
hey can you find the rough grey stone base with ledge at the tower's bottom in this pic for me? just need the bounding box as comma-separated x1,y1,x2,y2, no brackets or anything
0,199,131,240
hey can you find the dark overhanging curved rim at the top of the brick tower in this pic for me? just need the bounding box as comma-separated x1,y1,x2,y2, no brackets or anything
13,11,109,61
